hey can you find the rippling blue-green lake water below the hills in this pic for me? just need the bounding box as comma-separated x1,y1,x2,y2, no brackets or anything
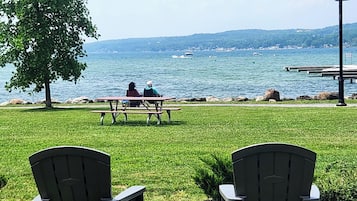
0,48,357,103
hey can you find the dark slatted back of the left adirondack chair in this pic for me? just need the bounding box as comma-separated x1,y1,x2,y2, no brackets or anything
29,147,112,201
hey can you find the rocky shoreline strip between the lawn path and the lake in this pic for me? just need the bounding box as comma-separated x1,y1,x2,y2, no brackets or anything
0,89,357,106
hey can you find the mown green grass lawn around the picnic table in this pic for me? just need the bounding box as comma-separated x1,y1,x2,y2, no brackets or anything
0,106,357,201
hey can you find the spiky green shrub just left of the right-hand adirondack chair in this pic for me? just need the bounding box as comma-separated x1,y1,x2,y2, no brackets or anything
193,154,233,200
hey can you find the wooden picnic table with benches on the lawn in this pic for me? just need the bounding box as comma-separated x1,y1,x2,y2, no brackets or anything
92,96,180,125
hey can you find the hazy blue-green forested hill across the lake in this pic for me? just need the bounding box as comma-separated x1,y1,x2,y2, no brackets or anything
85,23,357,52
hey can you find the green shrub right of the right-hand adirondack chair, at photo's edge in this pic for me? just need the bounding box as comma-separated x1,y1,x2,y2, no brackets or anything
318,161,357,201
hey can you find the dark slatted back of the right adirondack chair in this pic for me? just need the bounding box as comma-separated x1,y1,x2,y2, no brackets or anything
232,143,316,201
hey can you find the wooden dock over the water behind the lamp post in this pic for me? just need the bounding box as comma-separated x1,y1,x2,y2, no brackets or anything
285,65,357,83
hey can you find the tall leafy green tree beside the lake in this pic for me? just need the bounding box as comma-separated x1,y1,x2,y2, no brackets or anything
0,0,99,107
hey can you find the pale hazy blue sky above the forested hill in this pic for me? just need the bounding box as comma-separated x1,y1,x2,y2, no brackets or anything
87,0,357,42
